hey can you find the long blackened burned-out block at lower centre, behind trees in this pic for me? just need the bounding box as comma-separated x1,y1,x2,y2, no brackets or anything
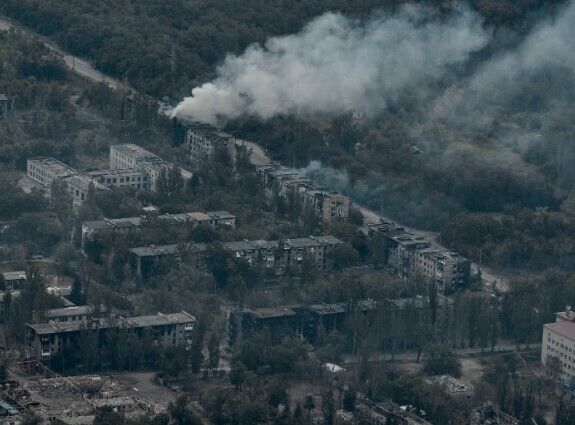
228,300,378,345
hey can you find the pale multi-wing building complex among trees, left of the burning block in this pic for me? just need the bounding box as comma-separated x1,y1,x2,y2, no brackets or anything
27,143,192,206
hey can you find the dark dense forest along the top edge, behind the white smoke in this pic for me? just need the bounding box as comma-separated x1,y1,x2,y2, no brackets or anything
0,0,562,96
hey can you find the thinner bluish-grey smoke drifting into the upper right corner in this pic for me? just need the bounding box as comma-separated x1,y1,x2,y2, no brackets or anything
429,1,575,129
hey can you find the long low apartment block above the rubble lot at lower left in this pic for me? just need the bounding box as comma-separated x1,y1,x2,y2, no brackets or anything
26,312,196,361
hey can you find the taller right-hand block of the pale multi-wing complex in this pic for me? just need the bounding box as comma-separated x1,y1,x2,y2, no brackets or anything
110,143,192,191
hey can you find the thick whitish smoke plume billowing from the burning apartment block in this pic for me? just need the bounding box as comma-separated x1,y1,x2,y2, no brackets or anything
172,6,489,123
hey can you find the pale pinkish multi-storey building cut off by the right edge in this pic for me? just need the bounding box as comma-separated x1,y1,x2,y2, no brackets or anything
541,306,575,383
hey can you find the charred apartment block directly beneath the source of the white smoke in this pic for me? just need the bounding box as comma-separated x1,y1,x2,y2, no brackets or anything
185,122,236,166
